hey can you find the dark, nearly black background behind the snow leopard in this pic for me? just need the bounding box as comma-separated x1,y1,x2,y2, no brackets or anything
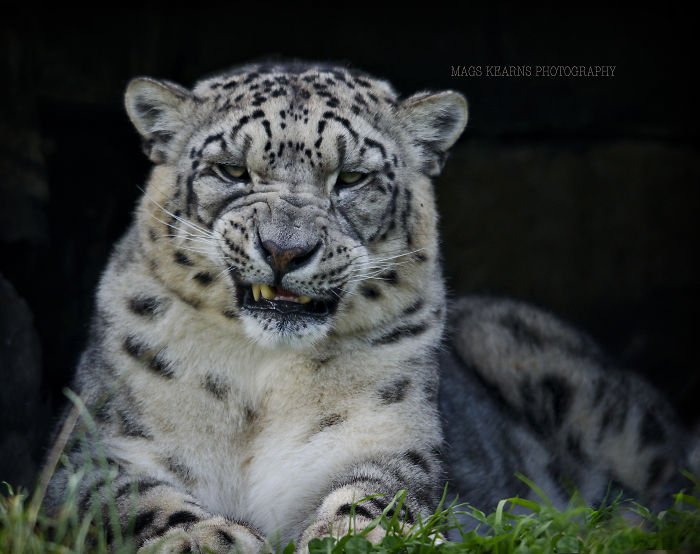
0,6,700,486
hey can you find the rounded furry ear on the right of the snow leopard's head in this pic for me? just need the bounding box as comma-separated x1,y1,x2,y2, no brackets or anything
399,90,469,177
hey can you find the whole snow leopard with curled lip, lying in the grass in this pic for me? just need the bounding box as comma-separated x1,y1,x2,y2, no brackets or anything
46,61,686,552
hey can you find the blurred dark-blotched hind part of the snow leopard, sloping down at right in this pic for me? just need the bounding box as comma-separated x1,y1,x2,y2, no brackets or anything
451,297,700,507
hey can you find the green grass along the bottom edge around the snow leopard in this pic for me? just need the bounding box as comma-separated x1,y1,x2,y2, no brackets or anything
0,473,700,554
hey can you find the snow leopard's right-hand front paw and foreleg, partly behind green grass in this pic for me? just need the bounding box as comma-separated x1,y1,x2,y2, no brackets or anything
297,451,441,552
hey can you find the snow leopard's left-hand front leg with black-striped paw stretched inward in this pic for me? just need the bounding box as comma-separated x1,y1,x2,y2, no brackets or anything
44,350,269,554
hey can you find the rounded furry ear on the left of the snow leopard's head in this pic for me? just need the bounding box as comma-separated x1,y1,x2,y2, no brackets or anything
124,77,192,164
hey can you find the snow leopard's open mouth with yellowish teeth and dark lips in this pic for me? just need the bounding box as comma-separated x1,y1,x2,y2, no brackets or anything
237,283,338,319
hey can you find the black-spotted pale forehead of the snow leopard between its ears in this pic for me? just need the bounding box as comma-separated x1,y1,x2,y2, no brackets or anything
193,67,397,179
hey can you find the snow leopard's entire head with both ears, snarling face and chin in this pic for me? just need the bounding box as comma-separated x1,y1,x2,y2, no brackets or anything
126,60,467,345
